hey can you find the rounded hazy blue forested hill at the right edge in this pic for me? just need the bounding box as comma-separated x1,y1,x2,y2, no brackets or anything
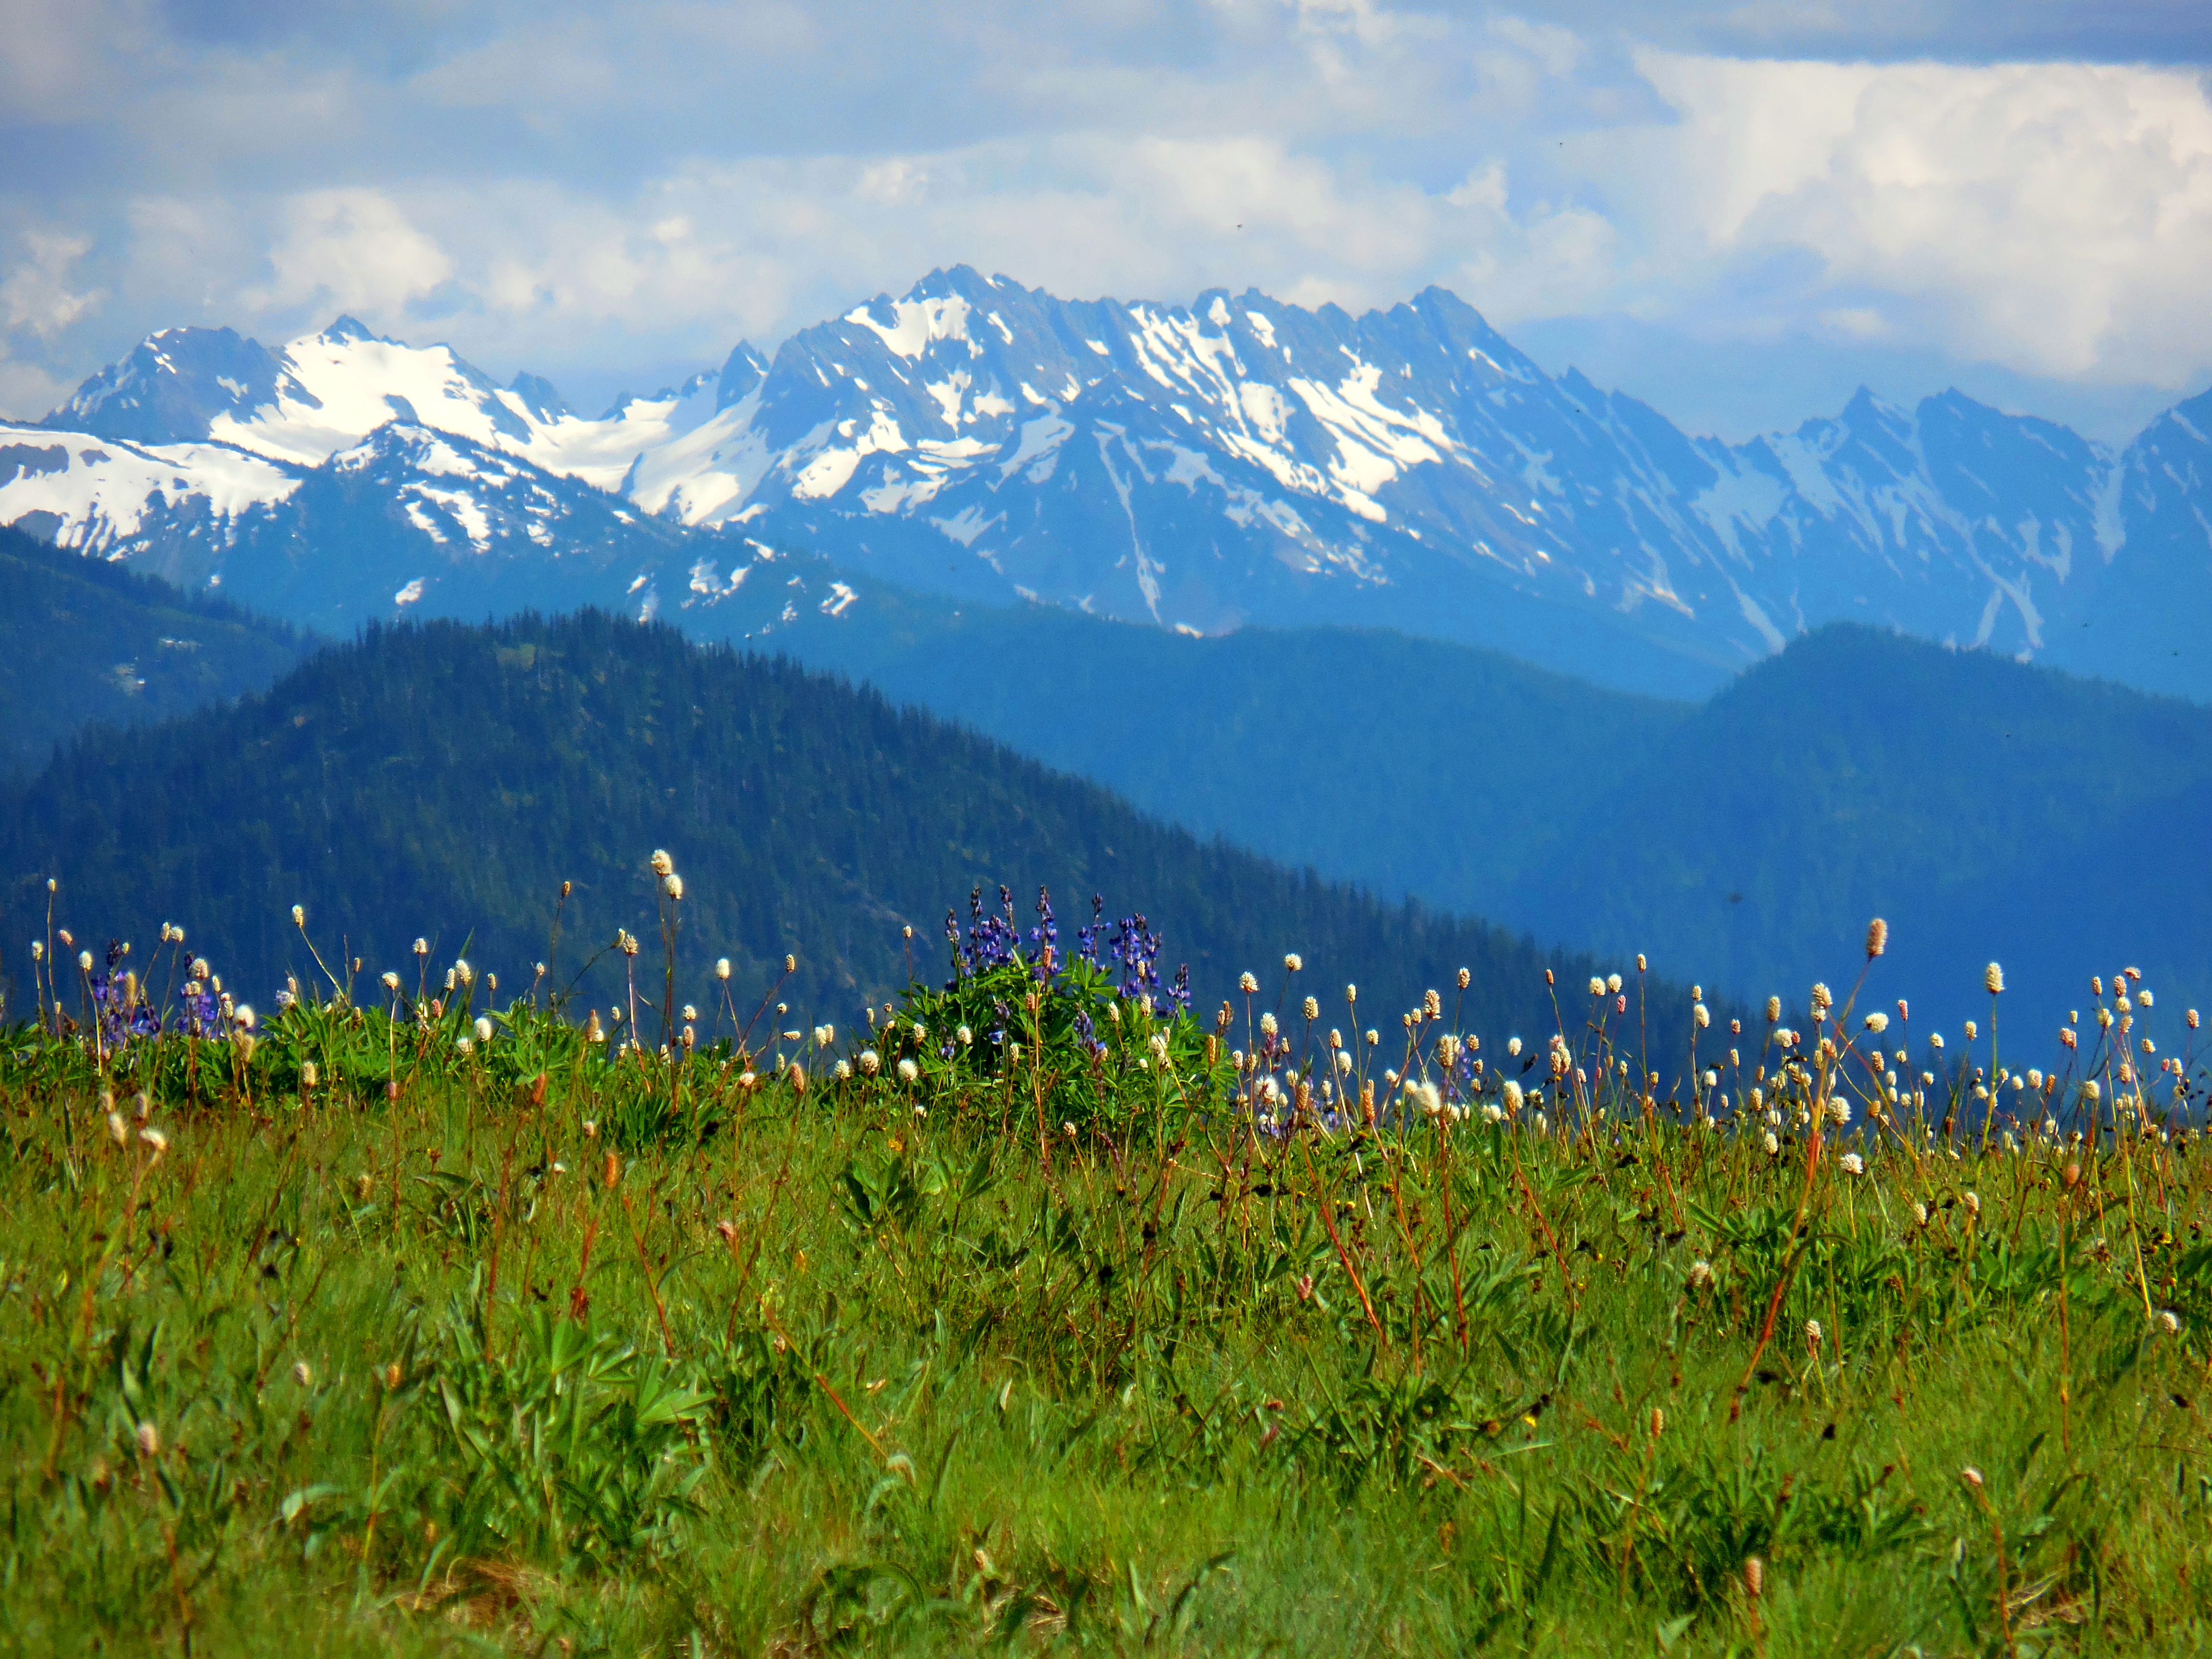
1504,626,2212,1020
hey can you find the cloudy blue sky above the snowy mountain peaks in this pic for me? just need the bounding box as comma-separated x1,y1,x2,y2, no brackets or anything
0,0,2212,443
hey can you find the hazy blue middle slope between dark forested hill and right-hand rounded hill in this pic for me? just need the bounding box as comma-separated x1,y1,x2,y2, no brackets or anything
716,584,1690,938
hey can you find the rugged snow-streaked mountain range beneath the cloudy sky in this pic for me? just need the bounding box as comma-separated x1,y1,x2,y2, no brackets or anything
0,268,2212,699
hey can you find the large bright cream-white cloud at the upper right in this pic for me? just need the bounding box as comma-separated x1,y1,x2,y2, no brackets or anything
1584,53,2212,387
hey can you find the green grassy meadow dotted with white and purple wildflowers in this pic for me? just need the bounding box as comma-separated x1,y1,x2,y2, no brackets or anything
0,929,2212,1655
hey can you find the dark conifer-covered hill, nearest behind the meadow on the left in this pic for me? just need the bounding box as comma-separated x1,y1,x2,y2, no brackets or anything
0,615,1628,1031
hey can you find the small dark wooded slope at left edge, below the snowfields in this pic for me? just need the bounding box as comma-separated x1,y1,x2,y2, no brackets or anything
0,529,312,776
